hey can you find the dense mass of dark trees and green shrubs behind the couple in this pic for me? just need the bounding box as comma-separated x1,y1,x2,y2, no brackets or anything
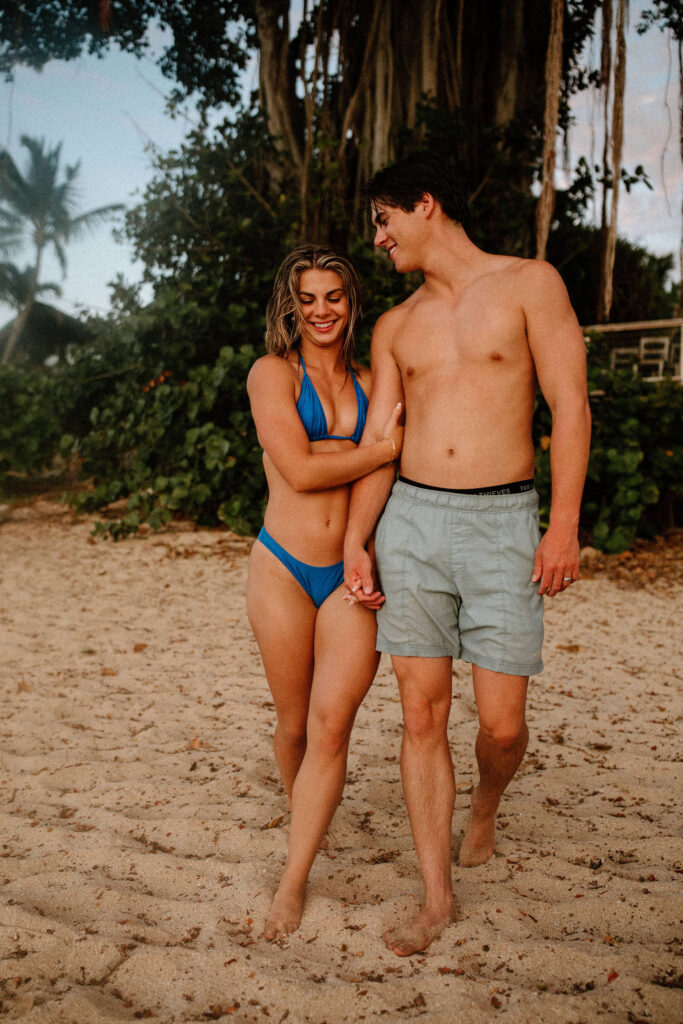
0,0,683,550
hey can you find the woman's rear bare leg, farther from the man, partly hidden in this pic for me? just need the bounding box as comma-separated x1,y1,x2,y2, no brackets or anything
247,541,317,807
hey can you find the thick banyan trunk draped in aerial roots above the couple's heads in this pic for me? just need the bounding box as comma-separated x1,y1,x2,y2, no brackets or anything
250,0,554,246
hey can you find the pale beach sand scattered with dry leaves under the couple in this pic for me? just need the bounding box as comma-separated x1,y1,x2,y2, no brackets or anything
0,501,683,1024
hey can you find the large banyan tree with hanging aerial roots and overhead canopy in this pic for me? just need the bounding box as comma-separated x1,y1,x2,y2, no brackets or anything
0,0,683,319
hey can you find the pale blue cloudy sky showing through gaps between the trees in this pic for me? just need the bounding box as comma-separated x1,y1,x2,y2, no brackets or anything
0,0,683,324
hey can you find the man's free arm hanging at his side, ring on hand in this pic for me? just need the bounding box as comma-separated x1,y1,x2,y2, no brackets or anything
523,263,591,597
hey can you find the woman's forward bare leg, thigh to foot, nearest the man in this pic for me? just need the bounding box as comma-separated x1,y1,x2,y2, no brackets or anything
263,587,379,939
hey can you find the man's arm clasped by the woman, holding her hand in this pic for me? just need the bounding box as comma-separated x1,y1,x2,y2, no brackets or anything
344,312,403,606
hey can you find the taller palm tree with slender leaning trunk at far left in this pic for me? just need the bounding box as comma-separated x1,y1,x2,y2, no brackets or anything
0,135,122,362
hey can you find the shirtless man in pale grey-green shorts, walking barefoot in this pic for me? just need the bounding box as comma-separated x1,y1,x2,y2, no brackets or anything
344,153,590,956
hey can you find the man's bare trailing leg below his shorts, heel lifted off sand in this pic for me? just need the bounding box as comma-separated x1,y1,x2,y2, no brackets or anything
459,665,528,867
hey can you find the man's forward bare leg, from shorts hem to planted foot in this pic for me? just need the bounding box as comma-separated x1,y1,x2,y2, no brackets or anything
384,656,456,956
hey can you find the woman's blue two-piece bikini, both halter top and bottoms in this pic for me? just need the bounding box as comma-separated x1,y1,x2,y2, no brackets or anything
258,354,368,608
